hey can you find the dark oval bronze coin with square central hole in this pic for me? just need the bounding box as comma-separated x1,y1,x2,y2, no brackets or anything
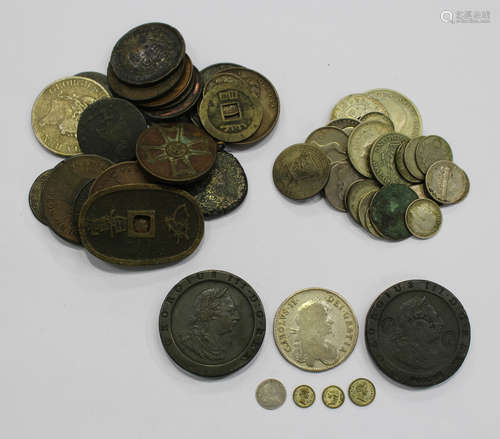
78,184,204,265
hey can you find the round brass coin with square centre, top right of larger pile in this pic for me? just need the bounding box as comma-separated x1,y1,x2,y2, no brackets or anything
198,84,263,142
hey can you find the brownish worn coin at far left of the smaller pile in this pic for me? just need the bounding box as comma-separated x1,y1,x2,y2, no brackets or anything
273,143,330,200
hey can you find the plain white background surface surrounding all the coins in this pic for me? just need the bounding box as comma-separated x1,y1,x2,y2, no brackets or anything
0,0,500,439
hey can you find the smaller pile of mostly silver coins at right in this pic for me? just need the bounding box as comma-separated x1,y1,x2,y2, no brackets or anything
273,89,469,240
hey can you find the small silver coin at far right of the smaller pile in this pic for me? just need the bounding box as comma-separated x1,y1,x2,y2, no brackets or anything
425,160,470,204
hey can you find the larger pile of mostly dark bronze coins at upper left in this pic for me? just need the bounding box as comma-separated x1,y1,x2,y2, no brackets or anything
29,23,279,265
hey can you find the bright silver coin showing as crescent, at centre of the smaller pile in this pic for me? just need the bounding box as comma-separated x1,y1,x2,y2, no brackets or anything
347,121,394,178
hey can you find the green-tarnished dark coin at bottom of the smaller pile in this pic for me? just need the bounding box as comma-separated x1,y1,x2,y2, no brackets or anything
370,184,418,240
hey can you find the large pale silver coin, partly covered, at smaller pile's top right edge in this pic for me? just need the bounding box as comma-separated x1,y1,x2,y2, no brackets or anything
365,88,422,139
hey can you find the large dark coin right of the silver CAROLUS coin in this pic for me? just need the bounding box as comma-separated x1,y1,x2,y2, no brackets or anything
365,280,470,387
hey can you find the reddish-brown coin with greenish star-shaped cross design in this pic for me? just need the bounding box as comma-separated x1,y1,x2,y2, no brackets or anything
137,122,217,183
